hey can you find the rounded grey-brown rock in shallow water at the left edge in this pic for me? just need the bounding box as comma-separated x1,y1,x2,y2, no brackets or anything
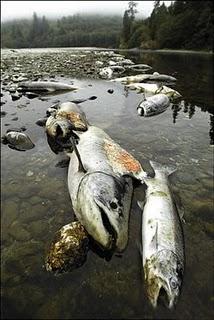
2,131,35,151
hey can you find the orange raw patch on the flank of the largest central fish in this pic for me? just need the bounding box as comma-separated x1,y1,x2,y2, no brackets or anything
104,141,142,173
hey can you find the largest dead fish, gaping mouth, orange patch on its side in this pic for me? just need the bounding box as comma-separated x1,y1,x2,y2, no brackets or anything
67,126,146,251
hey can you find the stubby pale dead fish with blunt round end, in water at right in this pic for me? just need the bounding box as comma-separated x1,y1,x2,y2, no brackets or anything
137,93,170,117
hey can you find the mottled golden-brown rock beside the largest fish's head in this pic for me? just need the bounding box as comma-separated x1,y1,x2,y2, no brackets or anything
45,221,89,274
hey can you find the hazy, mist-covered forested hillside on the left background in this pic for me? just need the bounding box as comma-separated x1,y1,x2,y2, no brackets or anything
1,13,122,48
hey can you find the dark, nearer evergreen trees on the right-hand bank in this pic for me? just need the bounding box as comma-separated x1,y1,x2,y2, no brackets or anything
121,0,213,50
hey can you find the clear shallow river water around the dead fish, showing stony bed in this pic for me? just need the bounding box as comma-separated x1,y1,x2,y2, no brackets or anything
1,50,214,319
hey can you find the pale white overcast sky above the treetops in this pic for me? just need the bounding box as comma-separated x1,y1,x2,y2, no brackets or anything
1,0,171,21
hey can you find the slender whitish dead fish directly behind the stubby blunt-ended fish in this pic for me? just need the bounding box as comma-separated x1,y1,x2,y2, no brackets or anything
126,83,181,99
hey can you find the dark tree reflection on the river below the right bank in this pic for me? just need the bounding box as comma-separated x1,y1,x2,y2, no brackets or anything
123,51,213,114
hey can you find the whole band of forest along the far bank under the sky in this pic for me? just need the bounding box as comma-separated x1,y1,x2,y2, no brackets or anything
1,0,213,51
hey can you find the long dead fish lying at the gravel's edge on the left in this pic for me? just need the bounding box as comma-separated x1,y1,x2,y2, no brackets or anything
18,81,78,92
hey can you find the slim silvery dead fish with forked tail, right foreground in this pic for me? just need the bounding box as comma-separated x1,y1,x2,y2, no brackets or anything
142,161,184,308
